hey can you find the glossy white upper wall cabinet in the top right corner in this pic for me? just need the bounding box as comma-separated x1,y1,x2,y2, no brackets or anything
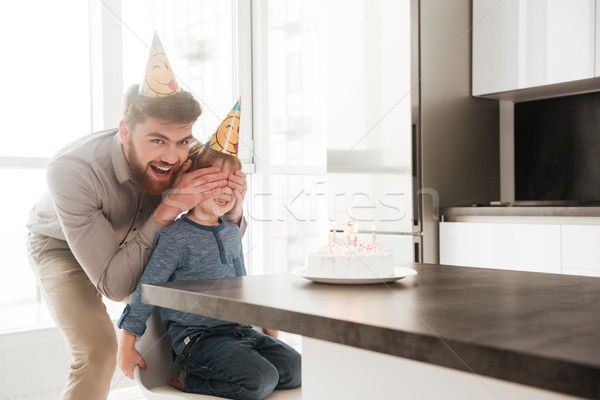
473,0,598,96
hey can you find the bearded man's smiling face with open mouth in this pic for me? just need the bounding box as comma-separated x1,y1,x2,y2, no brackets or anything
119,118,193,194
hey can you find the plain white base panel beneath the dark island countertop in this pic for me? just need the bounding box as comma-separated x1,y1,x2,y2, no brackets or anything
302,337,581,400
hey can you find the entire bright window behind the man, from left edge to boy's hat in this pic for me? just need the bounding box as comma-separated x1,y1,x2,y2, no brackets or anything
0,0,248,331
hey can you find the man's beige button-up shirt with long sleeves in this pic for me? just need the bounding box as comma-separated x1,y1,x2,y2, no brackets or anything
27,129,168,301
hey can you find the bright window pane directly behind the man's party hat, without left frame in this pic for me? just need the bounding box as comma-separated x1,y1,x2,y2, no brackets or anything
121,0,252,162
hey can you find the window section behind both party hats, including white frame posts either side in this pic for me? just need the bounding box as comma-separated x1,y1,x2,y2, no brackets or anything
91,0,253,161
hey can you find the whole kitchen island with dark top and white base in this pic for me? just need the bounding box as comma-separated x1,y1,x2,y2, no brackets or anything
143,264,600,400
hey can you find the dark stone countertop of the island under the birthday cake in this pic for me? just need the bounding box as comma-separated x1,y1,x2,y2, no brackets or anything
143,264,600,399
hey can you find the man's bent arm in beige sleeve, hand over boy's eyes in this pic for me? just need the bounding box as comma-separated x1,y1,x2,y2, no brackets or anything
47,159,227,301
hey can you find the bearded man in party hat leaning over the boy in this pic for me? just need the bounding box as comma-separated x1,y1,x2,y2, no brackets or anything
27,35,246,400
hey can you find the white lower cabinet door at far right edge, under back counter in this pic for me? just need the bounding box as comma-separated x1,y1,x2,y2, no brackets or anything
562,225,600,277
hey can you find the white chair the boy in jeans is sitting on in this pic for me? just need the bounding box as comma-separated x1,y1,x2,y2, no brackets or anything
133,307,302,400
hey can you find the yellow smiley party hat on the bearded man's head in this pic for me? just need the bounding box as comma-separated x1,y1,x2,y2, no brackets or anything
140,31,180,97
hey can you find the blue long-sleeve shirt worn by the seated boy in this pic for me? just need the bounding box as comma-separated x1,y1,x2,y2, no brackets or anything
118,217,246,354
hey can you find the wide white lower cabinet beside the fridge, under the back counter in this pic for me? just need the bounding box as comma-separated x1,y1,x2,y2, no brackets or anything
440,222,561,273
